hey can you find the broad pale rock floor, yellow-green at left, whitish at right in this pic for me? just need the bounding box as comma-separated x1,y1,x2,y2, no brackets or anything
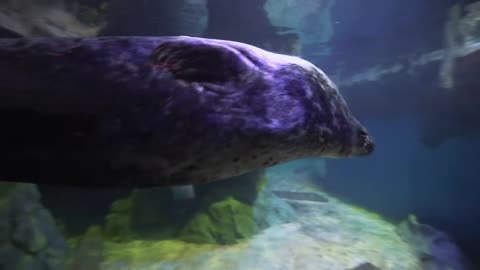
98,186,425,270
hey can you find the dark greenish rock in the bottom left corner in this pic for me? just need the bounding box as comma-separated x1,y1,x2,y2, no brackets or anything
0,183,68,270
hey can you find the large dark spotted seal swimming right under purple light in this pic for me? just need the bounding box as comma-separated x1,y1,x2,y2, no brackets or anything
0,36,374,186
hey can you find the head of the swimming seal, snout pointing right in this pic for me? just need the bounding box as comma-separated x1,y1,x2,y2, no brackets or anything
282,59,375,158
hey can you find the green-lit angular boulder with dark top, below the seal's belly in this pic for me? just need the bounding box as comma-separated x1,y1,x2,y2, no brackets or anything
179,171,267,245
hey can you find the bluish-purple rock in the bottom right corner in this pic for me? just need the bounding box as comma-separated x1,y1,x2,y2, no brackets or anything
396,215,473,270
